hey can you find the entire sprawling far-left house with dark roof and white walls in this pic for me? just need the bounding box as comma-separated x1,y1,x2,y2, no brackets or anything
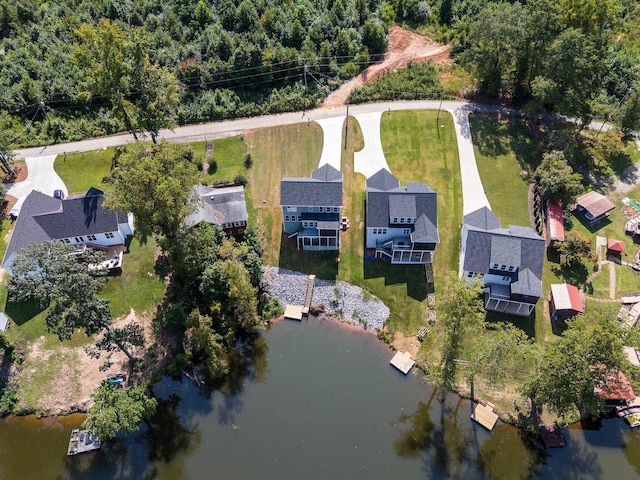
2,187,134,273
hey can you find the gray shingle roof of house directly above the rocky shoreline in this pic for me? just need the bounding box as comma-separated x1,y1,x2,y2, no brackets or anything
280,164,342,207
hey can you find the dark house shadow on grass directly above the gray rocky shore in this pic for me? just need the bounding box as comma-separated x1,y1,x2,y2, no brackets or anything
278,232,340,280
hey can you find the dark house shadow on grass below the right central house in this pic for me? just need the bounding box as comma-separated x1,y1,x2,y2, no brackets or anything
364,259,433,302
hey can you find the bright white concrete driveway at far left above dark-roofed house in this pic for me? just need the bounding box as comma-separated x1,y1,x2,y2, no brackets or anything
7,155,69,215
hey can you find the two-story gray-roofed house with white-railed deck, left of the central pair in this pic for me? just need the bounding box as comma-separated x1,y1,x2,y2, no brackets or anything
280,164,342,250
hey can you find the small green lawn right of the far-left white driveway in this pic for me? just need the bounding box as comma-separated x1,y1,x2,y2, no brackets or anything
54,148,115,195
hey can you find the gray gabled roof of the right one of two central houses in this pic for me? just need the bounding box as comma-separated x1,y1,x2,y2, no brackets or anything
366,169,440,243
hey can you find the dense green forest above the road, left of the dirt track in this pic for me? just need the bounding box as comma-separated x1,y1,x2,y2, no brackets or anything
0,0,389,145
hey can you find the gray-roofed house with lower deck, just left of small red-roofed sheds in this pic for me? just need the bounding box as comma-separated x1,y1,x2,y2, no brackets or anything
459,207,545,316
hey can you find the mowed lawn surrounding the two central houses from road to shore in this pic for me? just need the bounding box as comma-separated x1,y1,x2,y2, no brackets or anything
245,111,462,334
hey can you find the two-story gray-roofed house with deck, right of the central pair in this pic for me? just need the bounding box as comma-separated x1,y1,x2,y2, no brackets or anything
366,168,440,264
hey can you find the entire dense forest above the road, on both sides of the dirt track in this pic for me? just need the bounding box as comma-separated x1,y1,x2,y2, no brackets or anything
0,0,640,145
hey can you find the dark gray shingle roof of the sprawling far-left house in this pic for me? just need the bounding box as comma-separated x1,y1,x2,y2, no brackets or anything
3,188,127,265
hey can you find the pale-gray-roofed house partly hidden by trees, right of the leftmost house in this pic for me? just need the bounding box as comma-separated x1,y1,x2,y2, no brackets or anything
185,185,249,235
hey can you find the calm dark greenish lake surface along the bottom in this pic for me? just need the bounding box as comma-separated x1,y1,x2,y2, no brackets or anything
0,320,640,480
